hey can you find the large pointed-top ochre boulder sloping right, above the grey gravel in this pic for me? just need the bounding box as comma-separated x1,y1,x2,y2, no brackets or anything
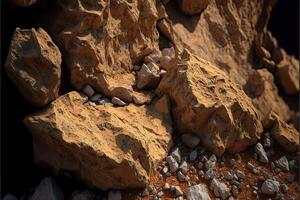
156,51,262,155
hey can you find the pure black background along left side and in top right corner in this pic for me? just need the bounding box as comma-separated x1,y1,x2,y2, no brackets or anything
1,0,299,198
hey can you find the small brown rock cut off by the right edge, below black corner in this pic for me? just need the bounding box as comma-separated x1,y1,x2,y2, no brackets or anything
276,55,299,95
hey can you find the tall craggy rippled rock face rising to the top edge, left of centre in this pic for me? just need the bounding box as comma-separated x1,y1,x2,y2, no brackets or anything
49,0,159,102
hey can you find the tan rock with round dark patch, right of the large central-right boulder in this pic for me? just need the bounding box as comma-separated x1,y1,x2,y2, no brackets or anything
244,69,290,127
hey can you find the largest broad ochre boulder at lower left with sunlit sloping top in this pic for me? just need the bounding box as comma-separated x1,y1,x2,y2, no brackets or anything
24,92,172,190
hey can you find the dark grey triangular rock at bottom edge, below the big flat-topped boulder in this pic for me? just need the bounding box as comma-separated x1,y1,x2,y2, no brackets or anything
31,177,64,200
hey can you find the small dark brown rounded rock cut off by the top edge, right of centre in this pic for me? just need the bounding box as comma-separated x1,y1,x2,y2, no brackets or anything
176,0,210,15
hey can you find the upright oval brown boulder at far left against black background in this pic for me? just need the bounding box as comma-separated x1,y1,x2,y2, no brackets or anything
5,28,61,106
